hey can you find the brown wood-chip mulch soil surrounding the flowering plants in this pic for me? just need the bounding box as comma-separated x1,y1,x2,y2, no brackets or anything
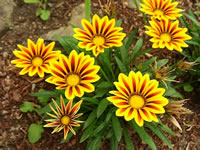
0,0,200,150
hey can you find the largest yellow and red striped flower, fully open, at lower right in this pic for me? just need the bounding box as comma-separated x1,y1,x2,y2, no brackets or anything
107,71,168,126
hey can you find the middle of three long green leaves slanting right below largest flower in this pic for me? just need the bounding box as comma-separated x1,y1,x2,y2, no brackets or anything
145,122,173,149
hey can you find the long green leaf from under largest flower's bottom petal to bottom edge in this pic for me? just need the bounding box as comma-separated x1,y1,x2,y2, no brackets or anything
129,120,156,150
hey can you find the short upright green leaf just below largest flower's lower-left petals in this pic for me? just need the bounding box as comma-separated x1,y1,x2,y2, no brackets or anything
112,115,122,142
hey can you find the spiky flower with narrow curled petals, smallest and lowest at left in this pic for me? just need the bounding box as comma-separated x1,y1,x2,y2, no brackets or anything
44,96,83,139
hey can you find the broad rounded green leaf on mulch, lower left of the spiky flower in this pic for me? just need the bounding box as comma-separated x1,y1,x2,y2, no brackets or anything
28,123,44,143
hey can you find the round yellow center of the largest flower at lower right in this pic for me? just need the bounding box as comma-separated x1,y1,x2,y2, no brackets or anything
129,95,145,109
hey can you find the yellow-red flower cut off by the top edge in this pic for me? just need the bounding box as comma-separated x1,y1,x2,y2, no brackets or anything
140,0,182,20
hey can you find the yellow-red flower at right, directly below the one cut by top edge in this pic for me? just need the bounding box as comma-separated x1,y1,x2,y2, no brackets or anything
145,19,191,52
